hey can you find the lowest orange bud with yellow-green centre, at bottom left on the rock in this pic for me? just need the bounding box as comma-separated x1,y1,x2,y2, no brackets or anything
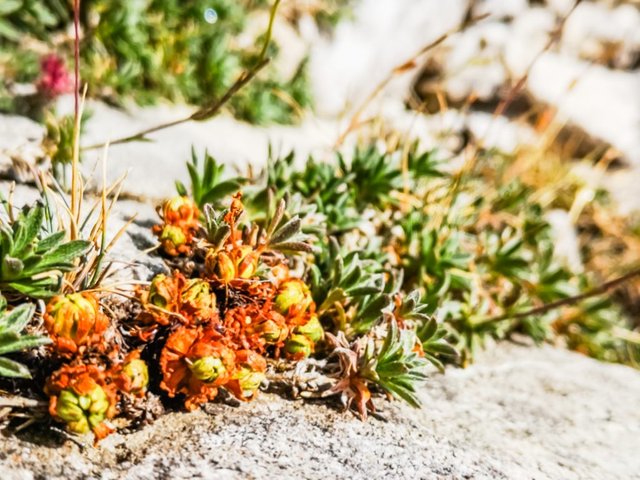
45,363,117,441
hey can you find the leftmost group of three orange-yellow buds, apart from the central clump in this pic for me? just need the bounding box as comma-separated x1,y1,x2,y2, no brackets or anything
44,292,154,441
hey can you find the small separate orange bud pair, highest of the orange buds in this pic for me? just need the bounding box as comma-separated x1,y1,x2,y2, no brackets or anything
153,196,200,257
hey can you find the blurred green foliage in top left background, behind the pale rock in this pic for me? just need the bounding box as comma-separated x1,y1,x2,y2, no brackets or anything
0,0,348,123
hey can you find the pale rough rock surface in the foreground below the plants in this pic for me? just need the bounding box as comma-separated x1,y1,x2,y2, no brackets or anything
0,343,640,480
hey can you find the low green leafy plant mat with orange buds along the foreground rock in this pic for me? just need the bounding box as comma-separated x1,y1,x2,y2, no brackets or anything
0,137,638,439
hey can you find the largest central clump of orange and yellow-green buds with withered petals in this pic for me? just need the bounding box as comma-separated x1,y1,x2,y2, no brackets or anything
136,195,324,410
